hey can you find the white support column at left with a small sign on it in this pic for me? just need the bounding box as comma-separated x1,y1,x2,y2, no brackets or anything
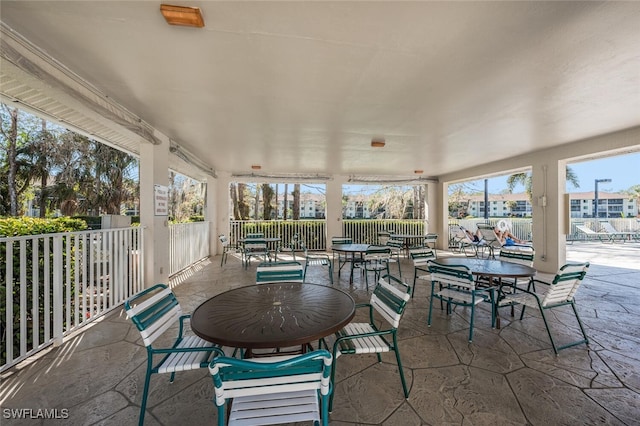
140,132,169,288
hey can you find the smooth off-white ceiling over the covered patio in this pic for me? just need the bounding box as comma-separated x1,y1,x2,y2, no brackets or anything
0,0,640,180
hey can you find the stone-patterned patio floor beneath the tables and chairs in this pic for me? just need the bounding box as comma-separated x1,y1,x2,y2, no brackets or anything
0,243,640,426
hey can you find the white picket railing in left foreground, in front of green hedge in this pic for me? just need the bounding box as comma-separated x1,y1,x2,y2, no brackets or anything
0,227,143,371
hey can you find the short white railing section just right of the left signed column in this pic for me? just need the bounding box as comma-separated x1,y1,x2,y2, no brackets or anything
169,222,210,276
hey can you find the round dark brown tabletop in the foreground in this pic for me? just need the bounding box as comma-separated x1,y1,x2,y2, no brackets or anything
191,283,355,350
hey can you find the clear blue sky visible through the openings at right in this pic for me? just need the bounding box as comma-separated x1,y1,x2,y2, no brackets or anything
470,153,640,194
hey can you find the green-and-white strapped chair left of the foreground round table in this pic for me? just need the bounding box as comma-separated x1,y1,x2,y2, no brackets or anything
124,284,224,426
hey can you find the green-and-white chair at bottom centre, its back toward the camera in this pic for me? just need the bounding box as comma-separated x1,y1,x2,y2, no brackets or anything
209,350,333,426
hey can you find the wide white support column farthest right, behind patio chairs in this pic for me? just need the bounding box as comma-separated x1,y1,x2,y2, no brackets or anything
531,157,566,273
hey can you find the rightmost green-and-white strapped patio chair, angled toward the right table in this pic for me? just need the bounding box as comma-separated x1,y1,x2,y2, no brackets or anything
496,262,589,355
